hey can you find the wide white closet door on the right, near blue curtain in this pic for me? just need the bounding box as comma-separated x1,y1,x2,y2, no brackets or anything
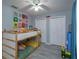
49,17,66,46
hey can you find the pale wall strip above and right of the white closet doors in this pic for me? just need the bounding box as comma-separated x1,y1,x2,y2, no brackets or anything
33,11,71,32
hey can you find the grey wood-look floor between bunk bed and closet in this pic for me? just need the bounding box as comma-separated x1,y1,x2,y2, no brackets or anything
27,44,62,59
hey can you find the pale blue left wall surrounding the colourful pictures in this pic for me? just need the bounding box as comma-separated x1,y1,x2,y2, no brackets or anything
2,4,34,30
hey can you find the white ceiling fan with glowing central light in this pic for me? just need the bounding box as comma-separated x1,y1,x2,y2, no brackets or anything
25,0,49,11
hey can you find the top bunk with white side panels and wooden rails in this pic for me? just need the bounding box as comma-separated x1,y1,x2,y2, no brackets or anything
2,30,40,41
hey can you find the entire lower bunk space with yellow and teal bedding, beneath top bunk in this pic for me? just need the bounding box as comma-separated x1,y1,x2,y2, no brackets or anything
18,37,40,59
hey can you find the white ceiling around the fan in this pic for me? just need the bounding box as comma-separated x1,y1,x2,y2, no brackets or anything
2,0,72,15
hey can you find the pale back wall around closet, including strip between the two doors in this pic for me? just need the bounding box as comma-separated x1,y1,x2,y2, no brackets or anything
35,11,71,45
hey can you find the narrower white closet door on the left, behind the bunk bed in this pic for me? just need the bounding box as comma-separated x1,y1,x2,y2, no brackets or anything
35,19,47,43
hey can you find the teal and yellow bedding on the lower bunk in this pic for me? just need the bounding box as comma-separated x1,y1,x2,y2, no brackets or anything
18,42,40,59
